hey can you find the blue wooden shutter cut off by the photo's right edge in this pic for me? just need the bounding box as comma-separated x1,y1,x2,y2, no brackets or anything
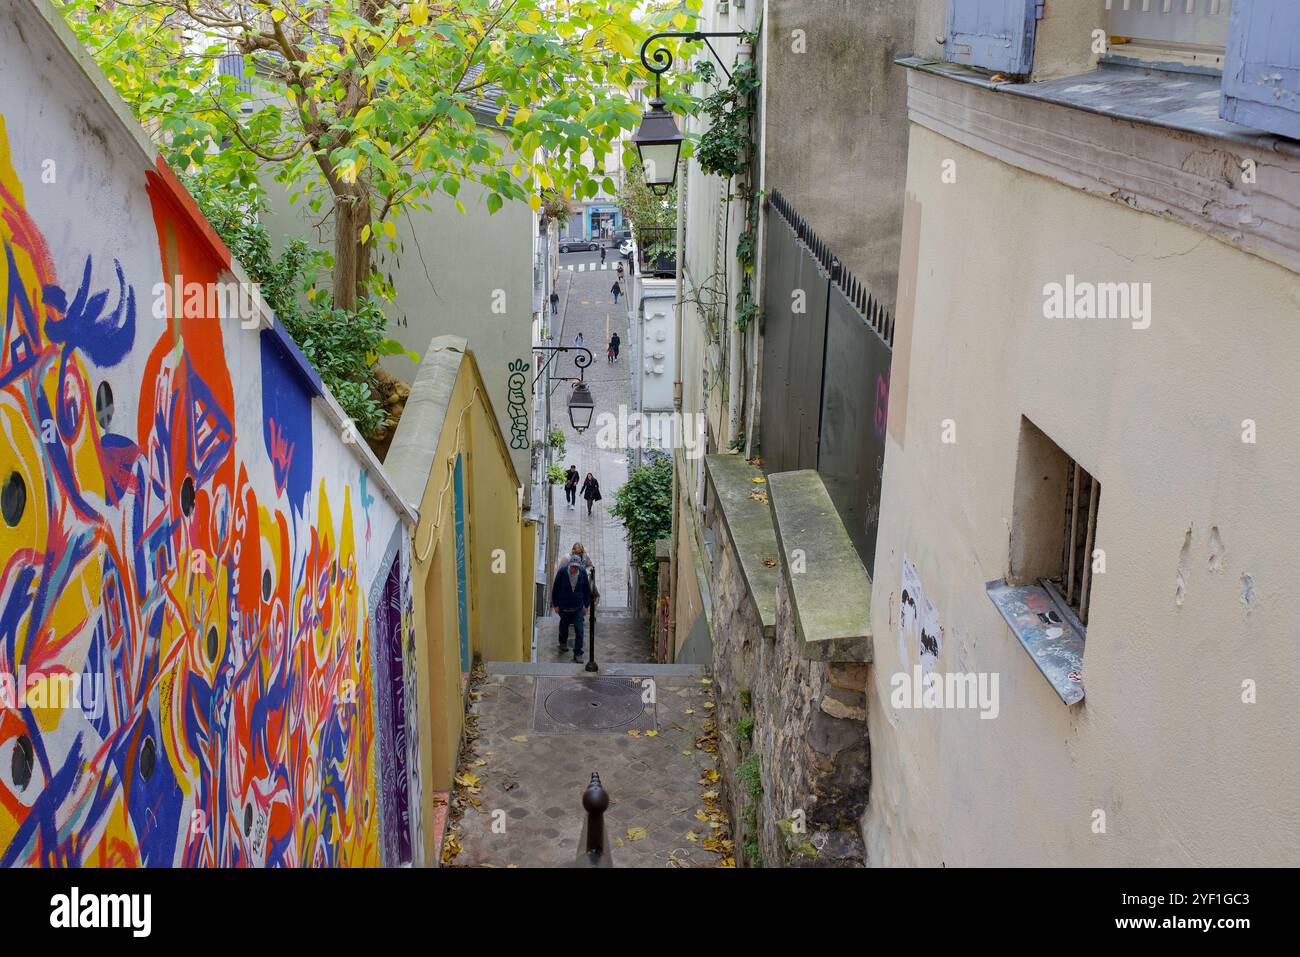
1219,0,1300,139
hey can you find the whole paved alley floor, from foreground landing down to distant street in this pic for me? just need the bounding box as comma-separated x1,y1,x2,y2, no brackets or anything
442,256,735,867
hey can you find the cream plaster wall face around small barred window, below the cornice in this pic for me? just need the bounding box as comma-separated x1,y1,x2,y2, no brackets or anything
863,126,1300,866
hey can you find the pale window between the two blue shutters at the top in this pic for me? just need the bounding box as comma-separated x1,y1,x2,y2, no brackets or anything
1102,0,1232,75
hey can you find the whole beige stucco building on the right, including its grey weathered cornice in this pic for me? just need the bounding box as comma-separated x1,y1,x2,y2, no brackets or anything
863,0,1300,866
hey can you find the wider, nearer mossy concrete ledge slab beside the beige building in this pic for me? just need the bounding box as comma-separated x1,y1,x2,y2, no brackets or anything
767,469,872,662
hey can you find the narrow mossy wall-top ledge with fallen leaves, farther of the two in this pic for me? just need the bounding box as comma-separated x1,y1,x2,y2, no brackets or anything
705,455,781,638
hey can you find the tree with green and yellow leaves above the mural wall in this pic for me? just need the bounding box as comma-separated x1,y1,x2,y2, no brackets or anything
62,0,698,309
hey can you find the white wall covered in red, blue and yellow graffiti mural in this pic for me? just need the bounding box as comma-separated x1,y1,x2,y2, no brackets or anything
0,4,411,866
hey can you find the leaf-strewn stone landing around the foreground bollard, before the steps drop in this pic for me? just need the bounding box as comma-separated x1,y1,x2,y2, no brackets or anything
445,674,735,867
